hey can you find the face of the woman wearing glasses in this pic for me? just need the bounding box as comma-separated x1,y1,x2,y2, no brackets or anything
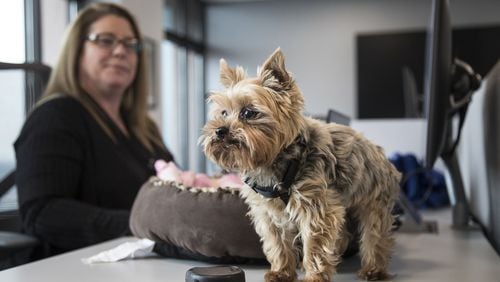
79,15,138,98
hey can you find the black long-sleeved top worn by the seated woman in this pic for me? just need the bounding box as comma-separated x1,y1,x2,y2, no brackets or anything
14,97,172,256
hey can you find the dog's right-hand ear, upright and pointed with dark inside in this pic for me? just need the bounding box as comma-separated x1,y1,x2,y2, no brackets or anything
257,47,293,91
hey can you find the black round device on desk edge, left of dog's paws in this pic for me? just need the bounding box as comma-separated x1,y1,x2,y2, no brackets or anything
186,266,245,282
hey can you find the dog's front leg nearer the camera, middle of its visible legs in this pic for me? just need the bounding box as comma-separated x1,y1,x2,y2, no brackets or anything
290,184,345,282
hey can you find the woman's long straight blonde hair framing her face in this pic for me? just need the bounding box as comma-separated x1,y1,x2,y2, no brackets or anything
42,3,165,152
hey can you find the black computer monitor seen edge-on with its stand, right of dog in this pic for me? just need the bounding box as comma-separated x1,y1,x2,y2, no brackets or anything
424,0,481,228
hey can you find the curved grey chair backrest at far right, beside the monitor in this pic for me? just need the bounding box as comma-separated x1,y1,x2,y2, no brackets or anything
458,61,500,254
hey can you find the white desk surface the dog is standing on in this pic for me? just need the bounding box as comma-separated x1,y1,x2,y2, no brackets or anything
0,210,500,282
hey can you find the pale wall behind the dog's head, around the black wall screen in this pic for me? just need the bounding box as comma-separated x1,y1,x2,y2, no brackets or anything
206,0,500,117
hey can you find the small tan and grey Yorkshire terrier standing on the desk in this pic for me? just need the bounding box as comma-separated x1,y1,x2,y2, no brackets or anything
200,48,400,281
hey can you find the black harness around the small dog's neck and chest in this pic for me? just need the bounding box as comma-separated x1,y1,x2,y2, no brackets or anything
244,159,299,206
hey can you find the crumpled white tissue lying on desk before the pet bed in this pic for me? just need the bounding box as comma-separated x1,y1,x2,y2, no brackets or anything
82,239,155,264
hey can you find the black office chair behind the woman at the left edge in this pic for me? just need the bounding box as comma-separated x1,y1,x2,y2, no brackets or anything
0,62,51,270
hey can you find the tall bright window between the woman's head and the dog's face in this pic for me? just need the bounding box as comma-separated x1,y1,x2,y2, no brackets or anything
162,0,205,172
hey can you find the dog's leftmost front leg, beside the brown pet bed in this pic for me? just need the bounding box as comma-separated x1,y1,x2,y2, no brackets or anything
250,199,297,282
